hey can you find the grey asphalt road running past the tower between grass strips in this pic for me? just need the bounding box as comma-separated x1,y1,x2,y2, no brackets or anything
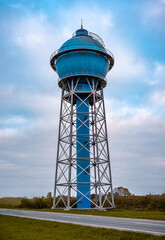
0,208,165,235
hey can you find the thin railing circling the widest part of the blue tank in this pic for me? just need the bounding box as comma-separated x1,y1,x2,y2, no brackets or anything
50,44,114,60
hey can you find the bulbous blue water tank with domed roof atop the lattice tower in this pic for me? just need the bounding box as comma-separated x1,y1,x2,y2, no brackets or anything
51,29,114,87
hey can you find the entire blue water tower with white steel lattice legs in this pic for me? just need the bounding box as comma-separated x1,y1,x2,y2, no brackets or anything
50,24,114,210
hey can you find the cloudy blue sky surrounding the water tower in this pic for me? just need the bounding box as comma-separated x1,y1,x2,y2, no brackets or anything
0,0,165,197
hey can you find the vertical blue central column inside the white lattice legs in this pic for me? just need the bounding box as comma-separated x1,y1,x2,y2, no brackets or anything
76,97,91,209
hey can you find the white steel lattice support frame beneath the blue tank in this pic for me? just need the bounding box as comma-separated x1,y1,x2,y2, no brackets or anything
52,77,114,210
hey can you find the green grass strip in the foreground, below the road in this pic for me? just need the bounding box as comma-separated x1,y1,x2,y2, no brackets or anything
0,215,165,240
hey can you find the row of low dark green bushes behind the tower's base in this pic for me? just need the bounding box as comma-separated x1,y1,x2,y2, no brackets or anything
19,194,165,211
